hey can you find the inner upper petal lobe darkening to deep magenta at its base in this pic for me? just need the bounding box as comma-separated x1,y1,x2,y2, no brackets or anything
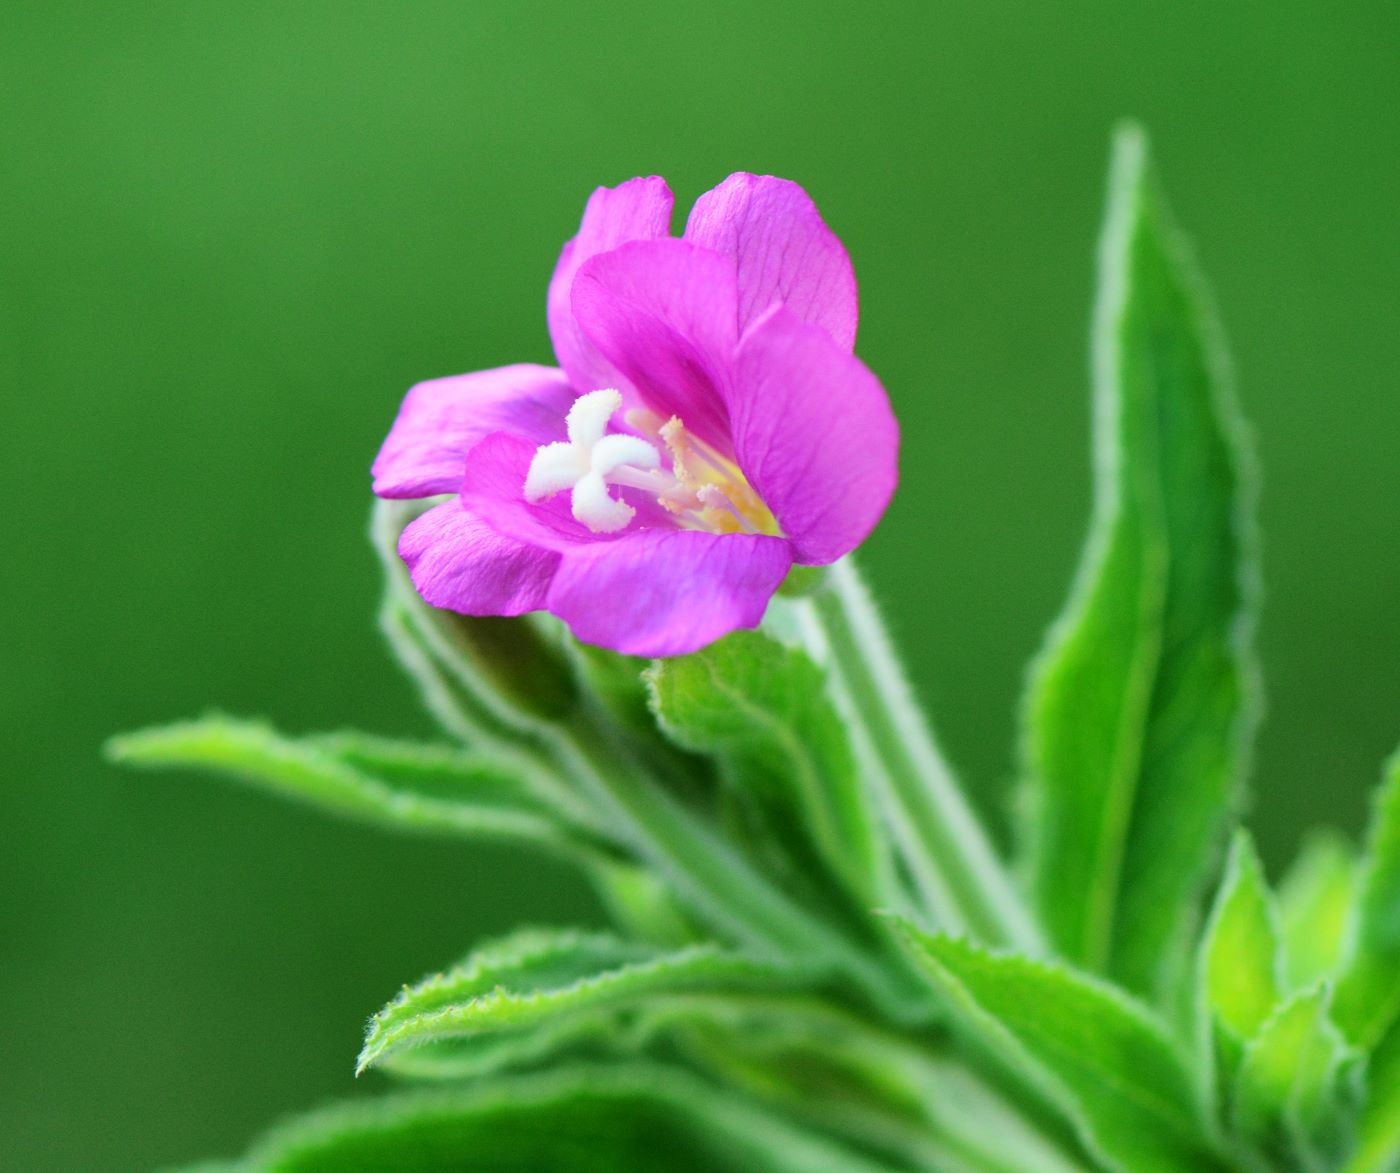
574,239,738,454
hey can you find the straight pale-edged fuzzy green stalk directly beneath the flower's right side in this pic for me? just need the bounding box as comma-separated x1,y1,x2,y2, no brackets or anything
797,559,1040,952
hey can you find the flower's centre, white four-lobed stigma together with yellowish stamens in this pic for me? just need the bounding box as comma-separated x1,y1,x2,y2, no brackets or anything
525,388,780,533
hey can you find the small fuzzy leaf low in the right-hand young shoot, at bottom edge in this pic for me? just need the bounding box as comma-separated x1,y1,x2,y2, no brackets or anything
1232,984,1362,1170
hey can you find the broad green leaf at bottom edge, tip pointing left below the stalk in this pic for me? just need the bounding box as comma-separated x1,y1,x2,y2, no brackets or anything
904,924,1224,1173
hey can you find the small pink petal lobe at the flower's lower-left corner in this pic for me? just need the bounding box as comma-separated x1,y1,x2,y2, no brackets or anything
399,500,559,614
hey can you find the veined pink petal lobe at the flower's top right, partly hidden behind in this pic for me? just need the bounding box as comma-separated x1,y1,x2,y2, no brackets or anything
686,172,857,350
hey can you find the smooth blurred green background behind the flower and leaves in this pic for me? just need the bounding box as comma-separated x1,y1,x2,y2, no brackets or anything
0,0,1400,1172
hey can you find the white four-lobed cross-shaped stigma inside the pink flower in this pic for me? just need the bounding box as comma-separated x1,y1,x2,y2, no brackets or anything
525,388,661,533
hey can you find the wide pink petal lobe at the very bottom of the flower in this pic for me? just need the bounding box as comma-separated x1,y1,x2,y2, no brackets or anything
549,529,792,656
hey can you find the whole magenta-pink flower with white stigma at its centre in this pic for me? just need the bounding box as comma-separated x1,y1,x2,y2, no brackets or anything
374,174,899,656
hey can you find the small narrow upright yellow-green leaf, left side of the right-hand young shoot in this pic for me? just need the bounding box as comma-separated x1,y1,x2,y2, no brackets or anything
1200,831,1282,1072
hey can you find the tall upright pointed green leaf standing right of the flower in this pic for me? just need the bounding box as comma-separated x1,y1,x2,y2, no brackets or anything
1023,127,1254,994
